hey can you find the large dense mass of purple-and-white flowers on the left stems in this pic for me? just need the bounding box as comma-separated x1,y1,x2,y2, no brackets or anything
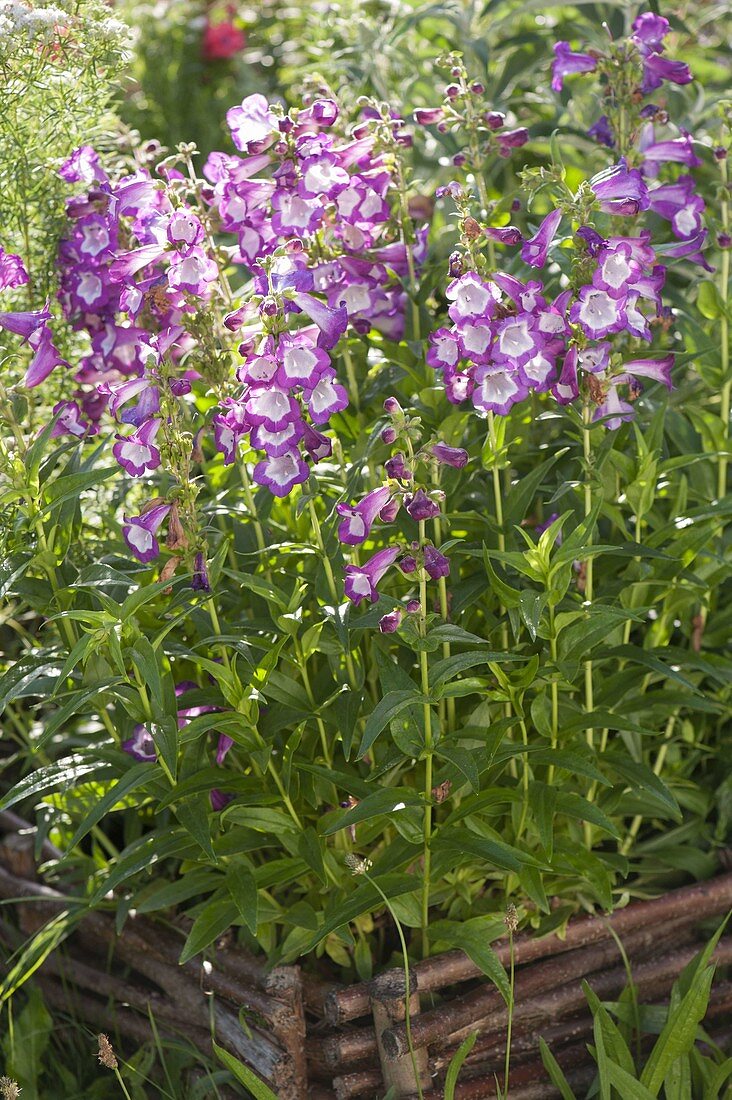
54,95,426,512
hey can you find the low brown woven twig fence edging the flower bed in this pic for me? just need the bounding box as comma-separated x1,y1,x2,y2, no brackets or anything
0,813,732,1100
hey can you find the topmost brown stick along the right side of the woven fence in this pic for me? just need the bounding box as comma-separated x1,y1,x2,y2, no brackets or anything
325,873,732,1025
